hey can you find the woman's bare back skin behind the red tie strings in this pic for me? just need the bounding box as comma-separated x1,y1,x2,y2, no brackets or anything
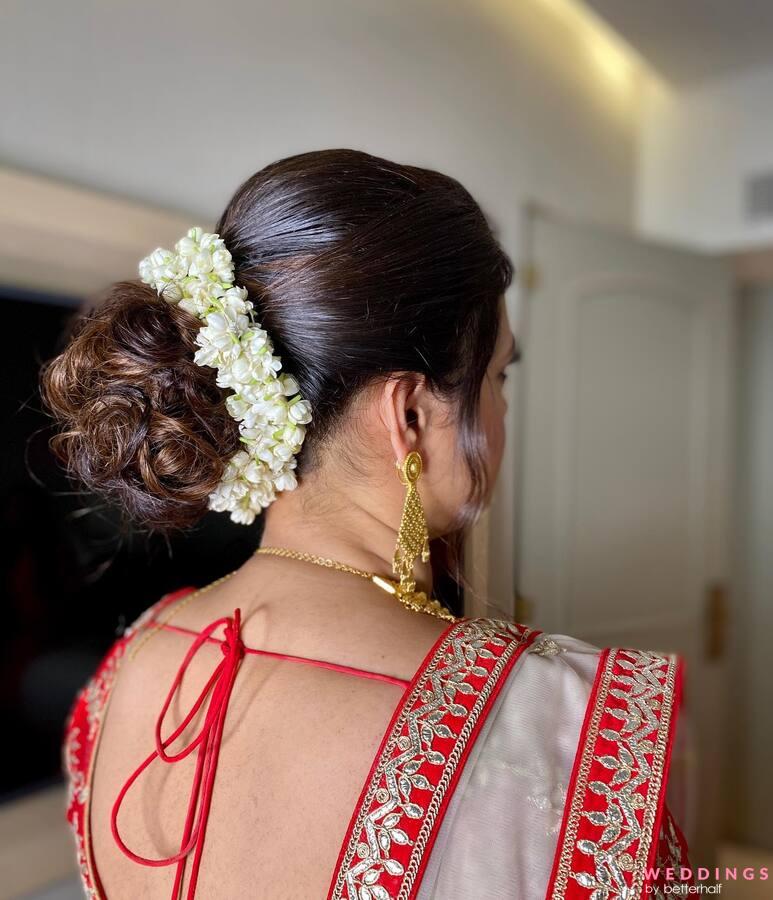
91,557,447,900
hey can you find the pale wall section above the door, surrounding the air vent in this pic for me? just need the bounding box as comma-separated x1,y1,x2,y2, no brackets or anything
636,67,773,252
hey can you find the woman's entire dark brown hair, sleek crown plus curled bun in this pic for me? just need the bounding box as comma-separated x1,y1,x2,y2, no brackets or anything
42,150,513,544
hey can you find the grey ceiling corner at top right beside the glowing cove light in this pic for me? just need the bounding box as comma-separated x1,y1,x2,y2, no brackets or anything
584,0,773,87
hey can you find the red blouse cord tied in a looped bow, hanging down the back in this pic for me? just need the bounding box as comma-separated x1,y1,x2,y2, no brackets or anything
110,609,244,900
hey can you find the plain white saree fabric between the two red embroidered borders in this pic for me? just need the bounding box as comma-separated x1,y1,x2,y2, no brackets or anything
417,637,599,900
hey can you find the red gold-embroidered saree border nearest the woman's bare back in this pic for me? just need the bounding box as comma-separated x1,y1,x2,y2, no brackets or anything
328,618,541,900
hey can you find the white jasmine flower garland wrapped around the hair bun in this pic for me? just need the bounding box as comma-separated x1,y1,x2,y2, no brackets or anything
140,228,311,525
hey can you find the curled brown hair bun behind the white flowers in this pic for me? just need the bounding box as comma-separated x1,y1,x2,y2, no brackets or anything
42,281,239,530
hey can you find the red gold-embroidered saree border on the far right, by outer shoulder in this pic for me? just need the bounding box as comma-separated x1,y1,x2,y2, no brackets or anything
547,649,683,900
